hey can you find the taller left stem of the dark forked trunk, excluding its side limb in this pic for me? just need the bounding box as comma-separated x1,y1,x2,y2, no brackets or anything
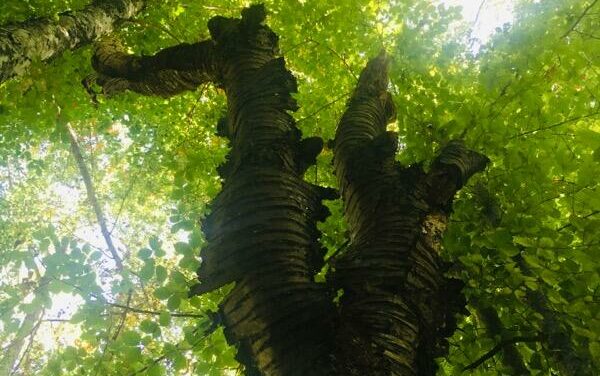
159,6,333,375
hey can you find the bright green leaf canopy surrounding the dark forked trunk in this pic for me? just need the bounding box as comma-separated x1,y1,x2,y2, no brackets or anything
0,0,600,375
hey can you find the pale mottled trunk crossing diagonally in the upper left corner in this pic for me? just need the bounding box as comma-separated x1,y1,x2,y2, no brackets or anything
0,0,145,83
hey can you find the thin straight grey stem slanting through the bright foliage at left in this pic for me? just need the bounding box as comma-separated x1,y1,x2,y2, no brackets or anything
65,123,123,270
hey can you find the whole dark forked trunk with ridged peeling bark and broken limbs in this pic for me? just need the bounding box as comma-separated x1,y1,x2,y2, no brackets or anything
93,6,487,376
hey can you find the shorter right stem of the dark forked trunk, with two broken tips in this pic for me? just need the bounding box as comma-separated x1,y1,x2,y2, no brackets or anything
332,54,487,375
